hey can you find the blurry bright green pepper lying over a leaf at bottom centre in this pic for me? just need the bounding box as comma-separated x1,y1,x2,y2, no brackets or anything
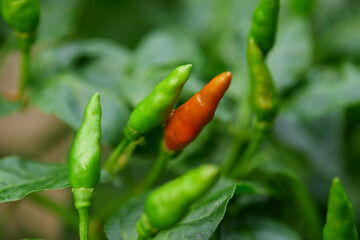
136,165,220,239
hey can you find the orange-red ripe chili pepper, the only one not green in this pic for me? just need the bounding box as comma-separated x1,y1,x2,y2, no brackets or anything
164,72,231,151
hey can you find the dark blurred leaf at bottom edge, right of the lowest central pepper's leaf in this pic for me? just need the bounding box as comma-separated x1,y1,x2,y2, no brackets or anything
220,217,301,240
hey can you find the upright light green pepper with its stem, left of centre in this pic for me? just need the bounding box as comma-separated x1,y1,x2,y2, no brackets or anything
68,93,101,240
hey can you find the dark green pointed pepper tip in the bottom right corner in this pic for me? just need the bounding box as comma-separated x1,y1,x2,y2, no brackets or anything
323,177,358,240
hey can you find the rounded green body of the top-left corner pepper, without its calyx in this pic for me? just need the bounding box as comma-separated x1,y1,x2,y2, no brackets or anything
1,0,40,32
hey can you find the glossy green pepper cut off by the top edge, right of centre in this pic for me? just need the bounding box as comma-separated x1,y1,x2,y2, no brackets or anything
249,0,280,56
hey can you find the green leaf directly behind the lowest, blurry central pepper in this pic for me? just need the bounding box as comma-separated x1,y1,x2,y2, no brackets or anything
105,179,256,240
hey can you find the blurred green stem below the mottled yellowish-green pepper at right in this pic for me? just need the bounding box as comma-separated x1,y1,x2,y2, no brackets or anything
230,131,263,178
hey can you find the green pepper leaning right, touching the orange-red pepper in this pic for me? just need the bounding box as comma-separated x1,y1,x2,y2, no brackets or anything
124,64,192,140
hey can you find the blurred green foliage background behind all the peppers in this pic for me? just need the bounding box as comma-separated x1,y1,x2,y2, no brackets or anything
0,0,360,239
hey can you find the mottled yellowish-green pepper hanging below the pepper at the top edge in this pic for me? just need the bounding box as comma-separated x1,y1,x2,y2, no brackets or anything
247,38,279,129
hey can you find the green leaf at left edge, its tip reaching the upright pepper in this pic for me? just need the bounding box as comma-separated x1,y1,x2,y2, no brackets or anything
0,156,70,202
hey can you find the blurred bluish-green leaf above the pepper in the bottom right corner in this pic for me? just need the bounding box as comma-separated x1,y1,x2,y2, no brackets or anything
274,109,343,179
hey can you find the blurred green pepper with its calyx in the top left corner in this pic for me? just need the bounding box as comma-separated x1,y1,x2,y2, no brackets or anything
1,0,40,51
